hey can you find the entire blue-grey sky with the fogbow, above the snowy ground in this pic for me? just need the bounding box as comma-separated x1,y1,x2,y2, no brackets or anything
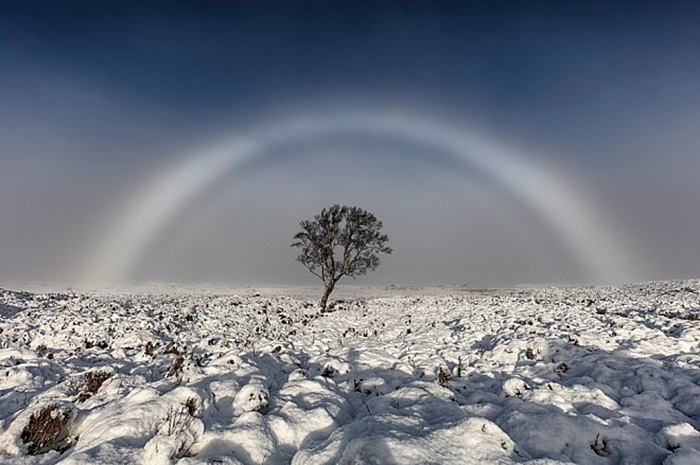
0,0,700,287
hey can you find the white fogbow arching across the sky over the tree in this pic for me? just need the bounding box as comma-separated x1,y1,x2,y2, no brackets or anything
85,111,632,282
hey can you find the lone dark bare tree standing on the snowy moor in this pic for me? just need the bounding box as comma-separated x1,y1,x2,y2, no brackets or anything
292,204,392,310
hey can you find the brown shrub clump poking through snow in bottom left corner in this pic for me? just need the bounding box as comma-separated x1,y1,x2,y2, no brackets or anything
20,404,73,455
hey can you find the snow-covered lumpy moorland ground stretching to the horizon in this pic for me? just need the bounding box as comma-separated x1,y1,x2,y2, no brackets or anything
0,281,700,465
